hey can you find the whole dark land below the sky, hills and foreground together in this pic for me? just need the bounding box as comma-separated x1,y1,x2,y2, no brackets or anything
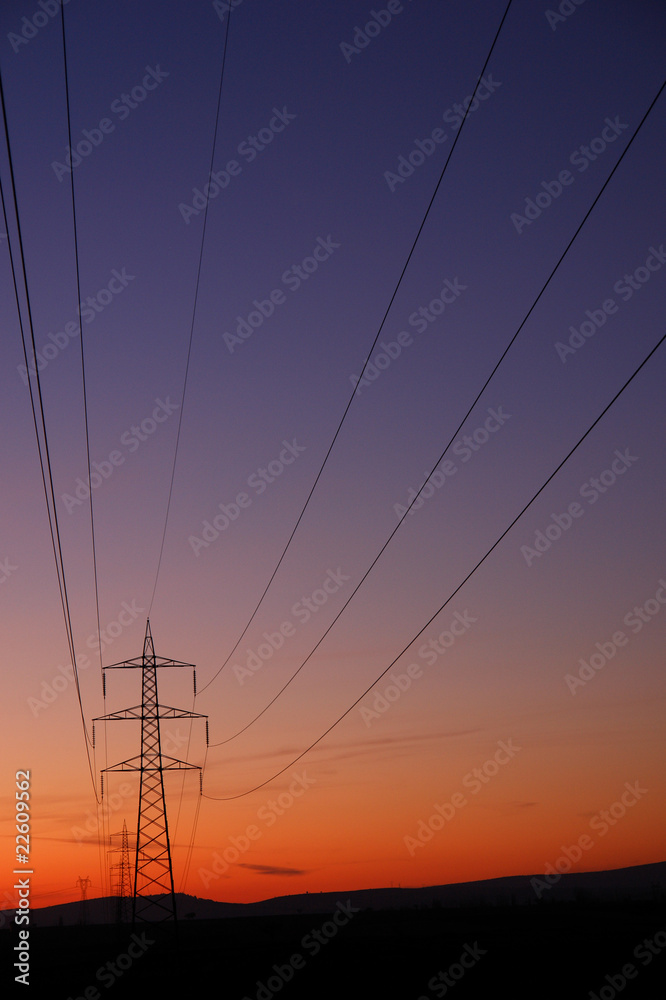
2,864,666,1000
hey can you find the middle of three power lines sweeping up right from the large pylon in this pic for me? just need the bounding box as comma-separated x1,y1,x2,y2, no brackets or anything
202,72,666,747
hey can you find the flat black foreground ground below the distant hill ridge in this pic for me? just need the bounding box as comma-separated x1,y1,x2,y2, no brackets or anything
1,897,666,1000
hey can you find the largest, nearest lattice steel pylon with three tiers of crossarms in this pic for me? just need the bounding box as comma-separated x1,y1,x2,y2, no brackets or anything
94,620,208,924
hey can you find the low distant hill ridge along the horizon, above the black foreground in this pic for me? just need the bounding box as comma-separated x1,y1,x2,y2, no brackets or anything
0,861,666,927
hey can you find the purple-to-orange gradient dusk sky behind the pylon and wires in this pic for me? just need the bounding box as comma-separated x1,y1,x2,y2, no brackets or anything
0,0,666,906
